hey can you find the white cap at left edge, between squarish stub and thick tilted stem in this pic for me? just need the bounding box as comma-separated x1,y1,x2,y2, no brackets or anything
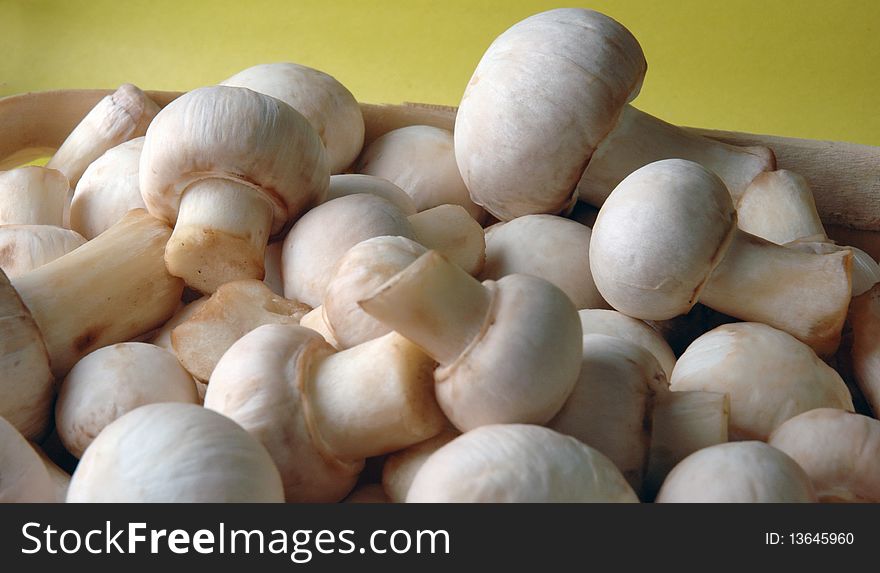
0,225,86,279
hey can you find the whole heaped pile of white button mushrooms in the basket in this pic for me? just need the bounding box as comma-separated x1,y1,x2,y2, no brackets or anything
0,8,880,503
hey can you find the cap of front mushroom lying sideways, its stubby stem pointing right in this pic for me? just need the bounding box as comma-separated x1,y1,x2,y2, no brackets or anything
205,324,363,502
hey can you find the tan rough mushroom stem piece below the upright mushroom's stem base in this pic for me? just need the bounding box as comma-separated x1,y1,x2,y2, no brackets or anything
171,279,311,382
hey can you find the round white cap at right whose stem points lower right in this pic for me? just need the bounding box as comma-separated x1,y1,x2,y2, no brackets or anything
590,159,737,320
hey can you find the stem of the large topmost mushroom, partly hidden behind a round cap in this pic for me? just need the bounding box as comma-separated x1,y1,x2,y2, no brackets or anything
577,105,776,207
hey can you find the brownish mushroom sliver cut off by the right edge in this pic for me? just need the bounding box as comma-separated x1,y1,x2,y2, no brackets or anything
849,285,880,416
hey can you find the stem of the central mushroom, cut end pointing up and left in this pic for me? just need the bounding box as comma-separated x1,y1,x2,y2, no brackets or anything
358,251,492,364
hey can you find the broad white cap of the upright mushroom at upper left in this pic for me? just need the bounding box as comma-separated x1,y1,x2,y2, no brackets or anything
139,86,330,233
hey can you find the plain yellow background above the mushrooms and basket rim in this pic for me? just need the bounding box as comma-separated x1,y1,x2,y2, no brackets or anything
0,0,880,145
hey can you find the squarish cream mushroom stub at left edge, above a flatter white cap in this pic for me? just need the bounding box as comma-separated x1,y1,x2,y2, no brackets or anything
0,165,70,227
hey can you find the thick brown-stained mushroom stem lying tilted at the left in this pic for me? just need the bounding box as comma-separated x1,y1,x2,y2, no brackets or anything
13,209,183,377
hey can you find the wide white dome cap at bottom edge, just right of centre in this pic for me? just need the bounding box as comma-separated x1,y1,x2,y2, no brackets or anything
406,424,638,503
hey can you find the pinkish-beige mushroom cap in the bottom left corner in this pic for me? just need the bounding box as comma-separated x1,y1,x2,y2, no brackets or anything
0,417,57,503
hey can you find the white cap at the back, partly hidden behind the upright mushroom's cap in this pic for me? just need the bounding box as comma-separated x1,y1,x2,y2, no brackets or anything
220,63,364,173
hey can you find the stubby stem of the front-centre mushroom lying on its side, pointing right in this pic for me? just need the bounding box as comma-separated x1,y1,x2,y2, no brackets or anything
306,332,444,460
